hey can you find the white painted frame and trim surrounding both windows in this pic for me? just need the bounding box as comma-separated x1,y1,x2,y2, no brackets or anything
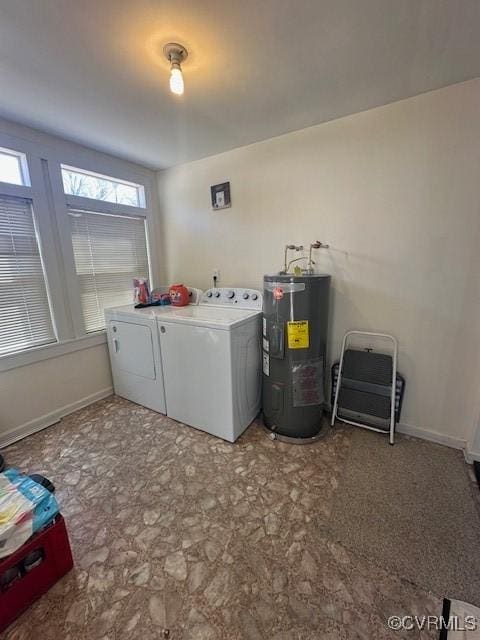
0,125,159,373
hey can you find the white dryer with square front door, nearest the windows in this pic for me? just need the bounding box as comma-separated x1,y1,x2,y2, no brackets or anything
105,287,202,413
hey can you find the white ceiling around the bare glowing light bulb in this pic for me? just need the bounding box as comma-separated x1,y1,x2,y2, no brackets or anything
0,0,480,168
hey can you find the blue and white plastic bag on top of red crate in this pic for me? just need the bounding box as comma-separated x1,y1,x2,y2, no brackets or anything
0,469,59,558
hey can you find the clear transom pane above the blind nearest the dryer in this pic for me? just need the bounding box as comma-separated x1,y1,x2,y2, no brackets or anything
62,165,145,208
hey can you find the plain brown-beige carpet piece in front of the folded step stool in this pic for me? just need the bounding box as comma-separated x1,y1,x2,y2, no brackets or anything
328,428,480,606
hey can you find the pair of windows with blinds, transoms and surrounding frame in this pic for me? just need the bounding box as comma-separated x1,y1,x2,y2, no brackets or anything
0,124,157,376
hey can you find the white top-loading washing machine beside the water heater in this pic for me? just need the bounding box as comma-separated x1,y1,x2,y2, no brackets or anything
157,289,262,442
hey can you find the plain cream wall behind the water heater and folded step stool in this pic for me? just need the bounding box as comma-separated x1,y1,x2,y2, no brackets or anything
159,80,480,446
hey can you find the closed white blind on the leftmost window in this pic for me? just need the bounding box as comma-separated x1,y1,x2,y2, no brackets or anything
0,195,56,355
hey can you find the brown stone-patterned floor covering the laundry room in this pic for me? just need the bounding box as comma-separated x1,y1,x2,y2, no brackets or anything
3,397,478,640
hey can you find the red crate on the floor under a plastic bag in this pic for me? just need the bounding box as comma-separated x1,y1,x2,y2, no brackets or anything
0,515,73,633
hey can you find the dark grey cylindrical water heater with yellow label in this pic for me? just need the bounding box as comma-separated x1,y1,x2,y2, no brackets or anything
263,273,330,442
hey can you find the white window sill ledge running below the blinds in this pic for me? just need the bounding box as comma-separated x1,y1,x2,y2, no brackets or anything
0,331,107,373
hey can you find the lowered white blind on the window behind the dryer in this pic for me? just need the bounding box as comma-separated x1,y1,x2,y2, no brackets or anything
70,209,149,332
